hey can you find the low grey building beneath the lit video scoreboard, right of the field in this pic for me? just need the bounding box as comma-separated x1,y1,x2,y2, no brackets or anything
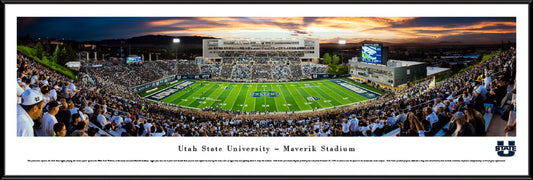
349,57,427,89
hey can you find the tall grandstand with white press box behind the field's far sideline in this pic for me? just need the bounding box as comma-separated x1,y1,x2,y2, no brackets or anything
196,38,327,82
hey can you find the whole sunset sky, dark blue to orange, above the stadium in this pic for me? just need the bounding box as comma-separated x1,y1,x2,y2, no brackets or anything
17,17,516,44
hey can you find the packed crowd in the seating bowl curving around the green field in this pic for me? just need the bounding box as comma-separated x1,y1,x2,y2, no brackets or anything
17,48,516,136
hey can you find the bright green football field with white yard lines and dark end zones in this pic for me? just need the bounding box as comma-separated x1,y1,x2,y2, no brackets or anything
141,79,381,112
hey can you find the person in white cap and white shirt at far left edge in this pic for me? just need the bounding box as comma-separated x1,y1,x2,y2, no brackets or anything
17,89,44,136
